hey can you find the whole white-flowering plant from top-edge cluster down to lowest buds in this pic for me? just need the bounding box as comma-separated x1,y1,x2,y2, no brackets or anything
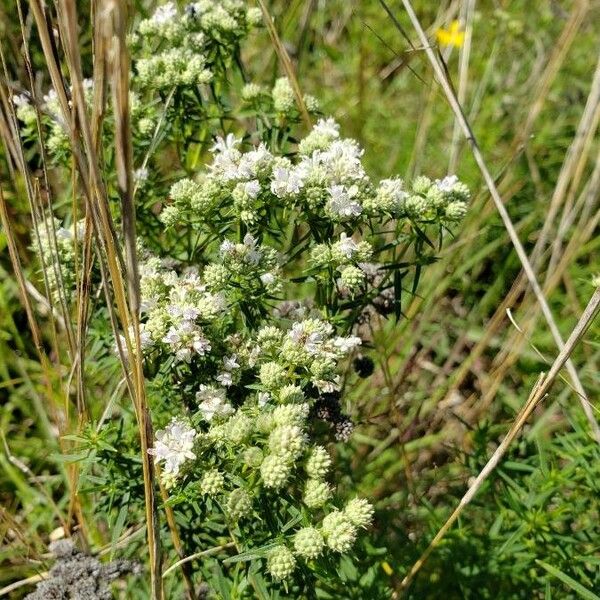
16,0,469,597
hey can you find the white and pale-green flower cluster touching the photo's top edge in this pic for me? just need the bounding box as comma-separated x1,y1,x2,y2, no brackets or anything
131,0,262,89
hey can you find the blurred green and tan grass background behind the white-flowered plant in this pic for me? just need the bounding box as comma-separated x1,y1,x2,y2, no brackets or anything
0,0,600,599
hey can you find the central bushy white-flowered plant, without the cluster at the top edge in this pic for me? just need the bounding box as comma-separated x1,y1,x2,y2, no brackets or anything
129,119,468,590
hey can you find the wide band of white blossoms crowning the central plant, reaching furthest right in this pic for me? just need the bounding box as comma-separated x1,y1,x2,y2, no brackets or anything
163,119,469,226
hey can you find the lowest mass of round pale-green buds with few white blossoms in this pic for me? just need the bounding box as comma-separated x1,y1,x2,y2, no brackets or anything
152,352,373,579
